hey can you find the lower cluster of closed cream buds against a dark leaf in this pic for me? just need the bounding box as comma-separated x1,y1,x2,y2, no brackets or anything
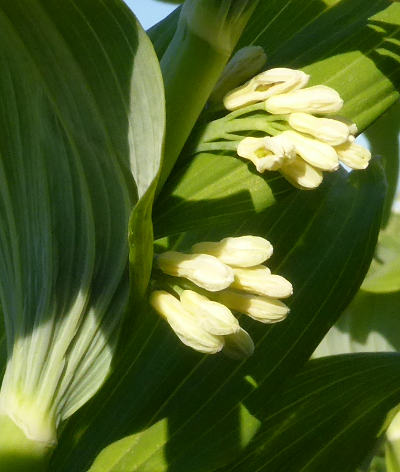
150,236,293,358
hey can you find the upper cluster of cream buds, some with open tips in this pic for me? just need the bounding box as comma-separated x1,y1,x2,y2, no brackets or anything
224,68,371,189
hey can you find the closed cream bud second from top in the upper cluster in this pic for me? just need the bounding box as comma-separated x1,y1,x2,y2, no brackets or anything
265,85,343,115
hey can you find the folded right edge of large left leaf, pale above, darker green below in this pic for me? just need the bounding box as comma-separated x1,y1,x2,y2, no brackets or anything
127,15,165,306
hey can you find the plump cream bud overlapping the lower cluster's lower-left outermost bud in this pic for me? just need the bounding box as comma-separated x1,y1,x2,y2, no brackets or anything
181,290,240,336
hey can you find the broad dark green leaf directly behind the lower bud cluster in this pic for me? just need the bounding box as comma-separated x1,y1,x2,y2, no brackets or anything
51,160,384,472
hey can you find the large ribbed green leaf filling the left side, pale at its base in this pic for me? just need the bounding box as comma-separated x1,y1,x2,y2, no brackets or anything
0,0,164,442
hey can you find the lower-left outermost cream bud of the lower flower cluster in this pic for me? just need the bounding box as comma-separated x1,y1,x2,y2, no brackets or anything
150,290,224,354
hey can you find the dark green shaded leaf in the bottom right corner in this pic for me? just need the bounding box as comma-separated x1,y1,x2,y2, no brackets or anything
218,354,400,472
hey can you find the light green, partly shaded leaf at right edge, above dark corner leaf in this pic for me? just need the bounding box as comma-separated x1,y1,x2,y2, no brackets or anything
314,213,400,357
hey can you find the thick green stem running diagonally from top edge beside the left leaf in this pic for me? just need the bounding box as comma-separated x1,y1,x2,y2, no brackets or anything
159,0,258,192
